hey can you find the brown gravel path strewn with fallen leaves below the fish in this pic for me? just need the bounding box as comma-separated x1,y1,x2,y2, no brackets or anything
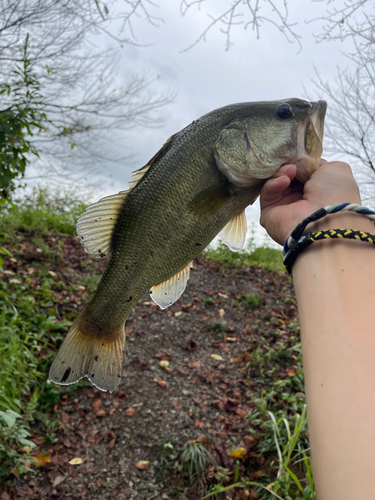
0,246,296,500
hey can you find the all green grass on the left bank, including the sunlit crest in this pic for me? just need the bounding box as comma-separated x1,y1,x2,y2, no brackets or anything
0,188,90,481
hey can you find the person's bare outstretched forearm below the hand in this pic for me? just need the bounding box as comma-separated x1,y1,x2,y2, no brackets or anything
293,214,375,500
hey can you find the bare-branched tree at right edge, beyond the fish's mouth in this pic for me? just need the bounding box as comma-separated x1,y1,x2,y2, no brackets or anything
306,0,375,199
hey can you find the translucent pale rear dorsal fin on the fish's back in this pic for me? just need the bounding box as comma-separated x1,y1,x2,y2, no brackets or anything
76,190,130,259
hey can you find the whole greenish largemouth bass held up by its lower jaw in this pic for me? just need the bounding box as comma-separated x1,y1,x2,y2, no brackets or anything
50,99,327,392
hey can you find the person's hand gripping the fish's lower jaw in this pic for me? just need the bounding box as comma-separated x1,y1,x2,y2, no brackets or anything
260,160,361,245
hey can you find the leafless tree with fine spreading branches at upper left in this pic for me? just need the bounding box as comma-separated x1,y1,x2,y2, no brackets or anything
0,0,174,193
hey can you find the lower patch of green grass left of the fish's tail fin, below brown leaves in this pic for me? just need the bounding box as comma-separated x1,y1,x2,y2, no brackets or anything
0,278,69,478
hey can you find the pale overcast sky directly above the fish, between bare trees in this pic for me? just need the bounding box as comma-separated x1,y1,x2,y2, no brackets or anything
63,0,362,247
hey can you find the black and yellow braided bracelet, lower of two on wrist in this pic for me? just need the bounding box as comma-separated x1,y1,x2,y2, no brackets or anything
283,229,375,274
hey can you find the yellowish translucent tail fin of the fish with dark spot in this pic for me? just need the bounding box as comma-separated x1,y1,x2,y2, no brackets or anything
49,313,125,392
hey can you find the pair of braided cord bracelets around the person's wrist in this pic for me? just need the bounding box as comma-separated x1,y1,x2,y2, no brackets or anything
283,203,375,274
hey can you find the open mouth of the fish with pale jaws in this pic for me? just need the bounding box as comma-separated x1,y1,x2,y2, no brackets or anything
290,101,327,183
